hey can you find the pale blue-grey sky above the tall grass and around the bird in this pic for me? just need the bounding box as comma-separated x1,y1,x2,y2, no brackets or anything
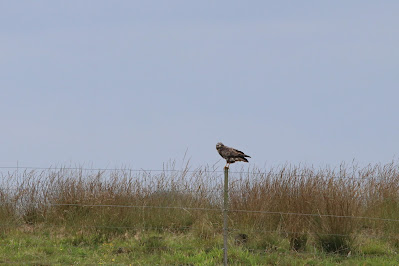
0,0,399,169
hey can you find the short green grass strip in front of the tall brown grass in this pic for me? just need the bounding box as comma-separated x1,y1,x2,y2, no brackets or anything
0,227,399,265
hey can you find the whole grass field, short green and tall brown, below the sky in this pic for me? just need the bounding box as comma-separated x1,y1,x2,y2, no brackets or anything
0,163,399,265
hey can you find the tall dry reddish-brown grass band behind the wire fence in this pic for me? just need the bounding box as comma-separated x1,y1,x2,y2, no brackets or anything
0,163,399,253
